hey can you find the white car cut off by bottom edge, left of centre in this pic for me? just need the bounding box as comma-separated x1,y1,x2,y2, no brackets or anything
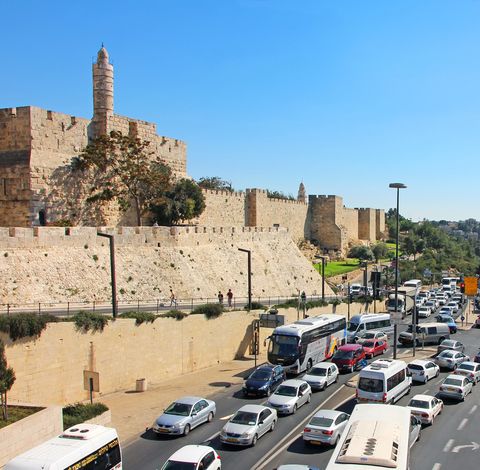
162,445,222,470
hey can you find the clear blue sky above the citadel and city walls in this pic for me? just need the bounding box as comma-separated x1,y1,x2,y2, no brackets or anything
0,0,480,220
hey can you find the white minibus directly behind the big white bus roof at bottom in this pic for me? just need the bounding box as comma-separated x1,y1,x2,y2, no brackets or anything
356,359,412,404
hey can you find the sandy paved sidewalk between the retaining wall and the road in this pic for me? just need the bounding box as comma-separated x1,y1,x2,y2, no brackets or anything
99,354,266,446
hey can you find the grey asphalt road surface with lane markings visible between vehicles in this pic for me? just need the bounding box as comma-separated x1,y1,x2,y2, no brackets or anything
123,300,480,470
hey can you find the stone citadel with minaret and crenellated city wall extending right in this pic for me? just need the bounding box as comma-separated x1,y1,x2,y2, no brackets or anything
0,46,385,252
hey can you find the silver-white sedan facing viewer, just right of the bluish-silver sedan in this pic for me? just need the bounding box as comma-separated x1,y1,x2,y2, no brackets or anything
220,405,277,446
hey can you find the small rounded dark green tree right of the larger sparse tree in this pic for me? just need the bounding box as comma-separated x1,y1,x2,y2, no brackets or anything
150,179,205,225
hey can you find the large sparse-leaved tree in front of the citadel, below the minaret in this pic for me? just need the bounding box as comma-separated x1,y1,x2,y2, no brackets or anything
72,131,171,225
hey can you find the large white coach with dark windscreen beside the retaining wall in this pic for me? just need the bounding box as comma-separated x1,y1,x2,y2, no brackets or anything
267,314,347,374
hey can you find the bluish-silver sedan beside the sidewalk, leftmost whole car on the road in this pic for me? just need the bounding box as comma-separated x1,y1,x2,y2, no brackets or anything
152,397,217,436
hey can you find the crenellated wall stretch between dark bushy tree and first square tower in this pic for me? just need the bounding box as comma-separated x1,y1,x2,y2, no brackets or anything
192,189,247,227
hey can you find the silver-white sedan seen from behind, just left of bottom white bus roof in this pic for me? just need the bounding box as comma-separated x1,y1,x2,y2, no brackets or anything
302,410,350,446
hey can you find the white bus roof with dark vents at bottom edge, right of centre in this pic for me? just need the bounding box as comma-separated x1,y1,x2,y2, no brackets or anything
325,405,412,470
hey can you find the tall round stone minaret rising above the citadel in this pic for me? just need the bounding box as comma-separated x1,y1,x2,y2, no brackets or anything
92,44,113,137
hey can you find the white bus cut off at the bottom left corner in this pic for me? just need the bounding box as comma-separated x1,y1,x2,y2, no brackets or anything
5,424,122,470
